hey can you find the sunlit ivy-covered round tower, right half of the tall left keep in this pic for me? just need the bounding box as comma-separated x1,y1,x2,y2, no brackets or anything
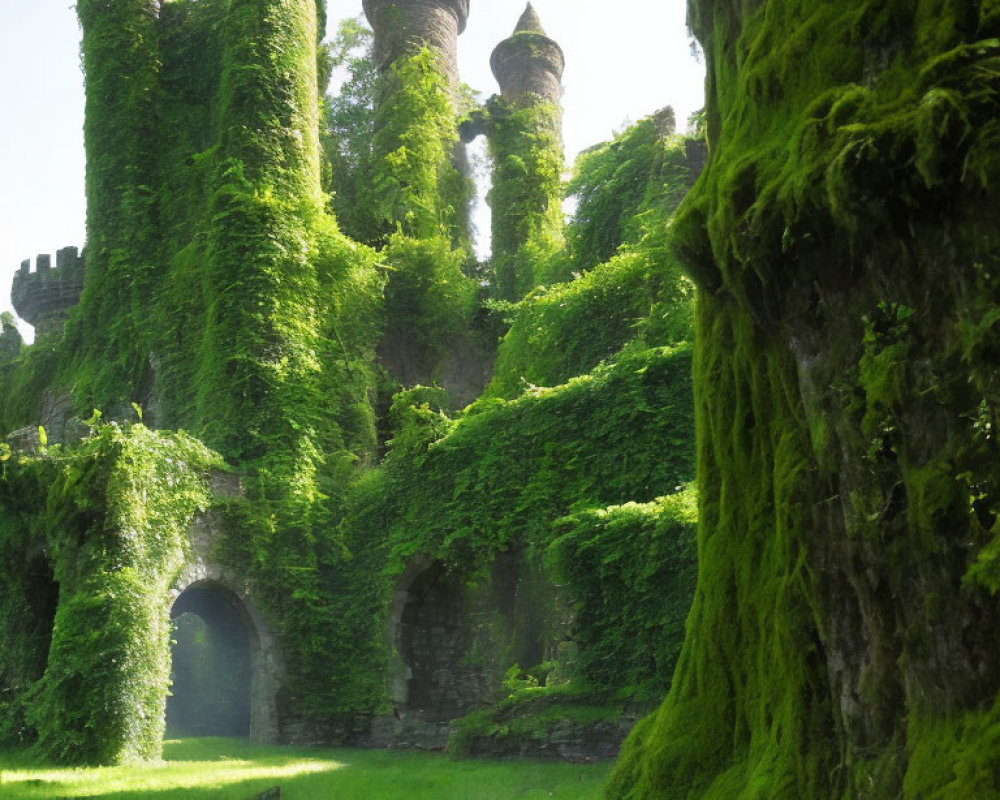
197,0,322,458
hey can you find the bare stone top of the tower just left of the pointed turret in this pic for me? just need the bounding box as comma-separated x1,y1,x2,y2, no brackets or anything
363,0,469,84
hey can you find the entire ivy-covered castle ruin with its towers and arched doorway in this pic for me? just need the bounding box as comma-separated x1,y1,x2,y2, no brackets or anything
0,0,693,763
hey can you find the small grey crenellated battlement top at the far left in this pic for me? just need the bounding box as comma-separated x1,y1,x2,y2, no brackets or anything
10,247,84,336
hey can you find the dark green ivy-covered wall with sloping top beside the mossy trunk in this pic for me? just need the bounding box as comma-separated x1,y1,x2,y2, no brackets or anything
341,345,693,712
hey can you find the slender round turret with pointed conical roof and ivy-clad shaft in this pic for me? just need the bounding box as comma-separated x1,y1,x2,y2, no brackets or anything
486,3,566,300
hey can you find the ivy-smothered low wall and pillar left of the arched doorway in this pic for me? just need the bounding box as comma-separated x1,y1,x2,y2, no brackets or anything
0,423,222,763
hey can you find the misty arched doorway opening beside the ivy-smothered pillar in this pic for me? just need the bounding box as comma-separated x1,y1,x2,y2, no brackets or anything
167,582,255,738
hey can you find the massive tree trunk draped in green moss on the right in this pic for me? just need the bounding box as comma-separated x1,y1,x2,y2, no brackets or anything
608,0,1000,800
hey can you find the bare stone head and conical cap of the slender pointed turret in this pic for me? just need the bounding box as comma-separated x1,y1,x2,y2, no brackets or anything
490,3,566,105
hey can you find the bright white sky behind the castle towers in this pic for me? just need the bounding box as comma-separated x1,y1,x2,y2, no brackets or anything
0,0,704,340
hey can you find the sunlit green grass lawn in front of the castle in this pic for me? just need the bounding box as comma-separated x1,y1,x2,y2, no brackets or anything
0,739,610,800
